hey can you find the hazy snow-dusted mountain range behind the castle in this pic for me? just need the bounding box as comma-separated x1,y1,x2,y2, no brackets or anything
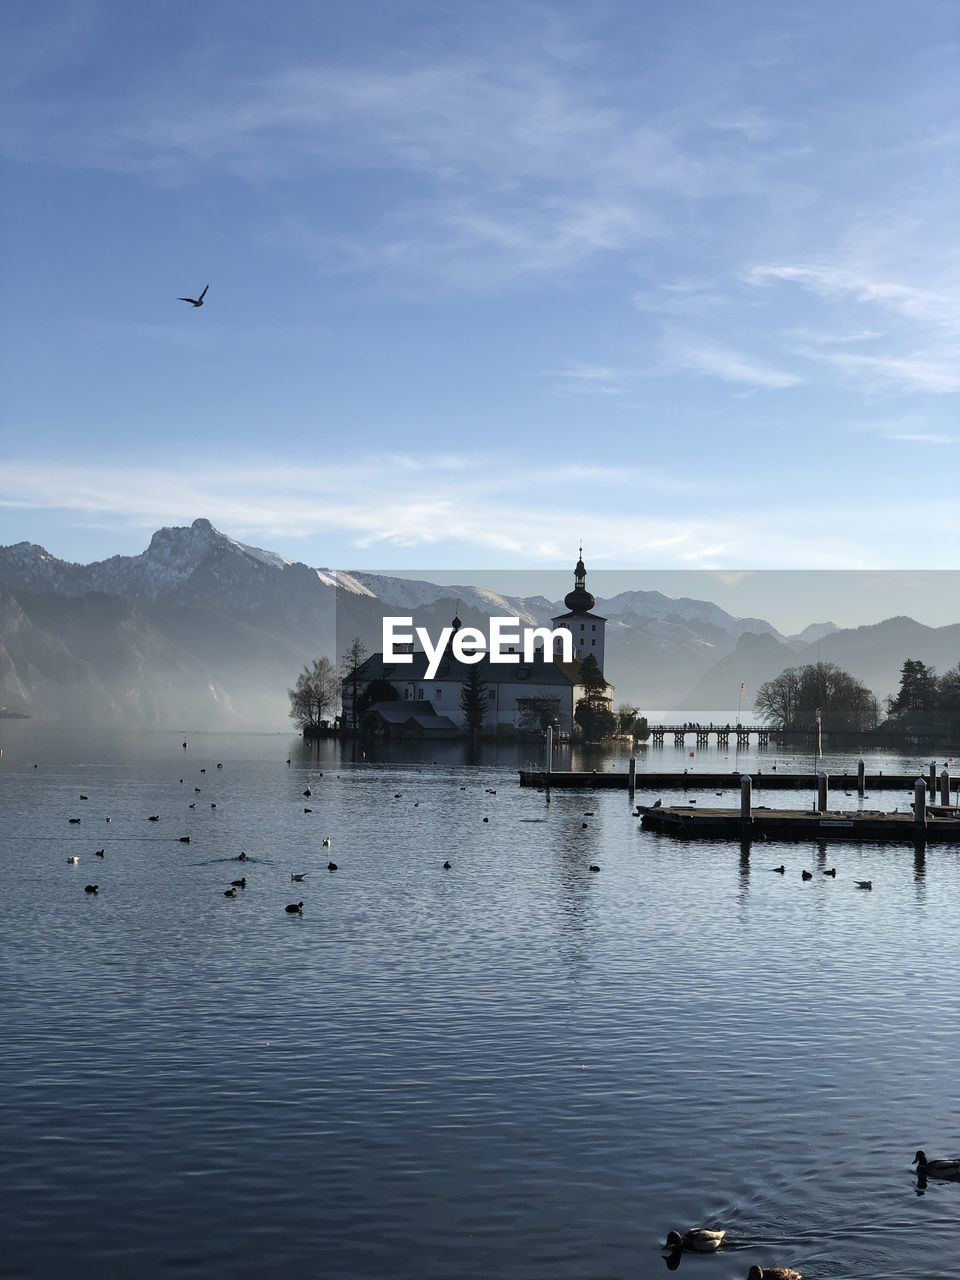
0,520,960,728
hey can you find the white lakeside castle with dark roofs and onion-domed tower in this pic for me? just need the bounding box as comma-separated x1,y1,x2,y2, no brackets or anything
340,548,607,737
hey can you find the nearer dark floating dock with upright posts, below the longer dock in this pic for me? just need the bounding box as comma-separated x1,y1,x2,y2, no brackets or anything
639,805,960,845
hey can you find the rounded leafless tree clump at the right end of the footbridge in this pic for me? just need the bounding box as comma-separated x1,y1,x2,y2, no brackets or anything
754,662,879,732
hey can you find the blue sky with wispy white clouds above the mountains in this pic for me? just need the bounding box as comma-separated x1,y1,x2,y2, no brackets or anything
0,0,960,570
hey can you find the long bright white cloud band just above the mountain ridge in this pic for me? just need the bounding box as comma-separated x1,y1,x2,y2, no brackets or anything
0,456,960,571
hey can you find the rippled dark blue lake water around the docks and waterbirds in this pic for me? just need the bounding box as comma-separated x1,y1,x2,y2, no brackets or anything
0,722,960,1280
